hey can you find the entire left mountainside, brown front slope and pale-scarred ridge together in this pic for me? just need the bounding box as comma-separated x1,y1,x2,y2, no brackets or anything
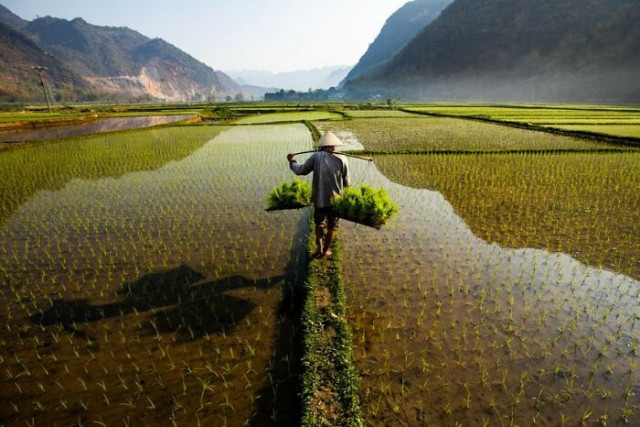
0,6,242,102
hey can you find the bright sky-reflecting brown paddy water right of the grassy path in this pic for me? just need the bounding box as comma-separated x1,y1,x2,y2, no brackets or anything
340,138,640,425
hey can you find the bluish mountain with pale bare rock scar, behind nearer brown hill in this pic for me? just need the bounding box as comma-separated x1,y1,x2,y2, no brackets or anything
0,4,242,101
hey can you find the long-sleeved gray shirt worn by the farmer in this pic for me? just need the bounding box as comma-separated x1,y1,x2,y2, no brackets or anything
289,151,351,208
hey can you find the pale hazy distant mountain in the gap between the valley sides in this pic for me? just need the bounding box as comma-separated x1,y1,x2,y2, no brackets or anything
227,65,351,91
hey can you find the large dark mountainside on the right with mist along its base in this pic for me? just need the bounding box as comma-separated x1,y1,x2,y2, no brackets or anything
344,0,640,102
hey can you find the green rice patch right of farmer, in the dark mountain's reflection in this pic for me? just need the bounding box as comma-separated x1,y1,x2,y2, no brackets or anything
376,153,640,279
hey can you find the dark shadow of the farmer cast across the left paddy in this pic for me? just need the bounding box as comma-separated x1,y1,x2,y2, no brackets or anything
29,264,283,342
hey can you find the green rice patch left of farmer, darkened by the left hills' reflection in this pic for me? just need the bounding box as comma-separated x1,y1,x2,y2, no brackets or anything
0,127,224,223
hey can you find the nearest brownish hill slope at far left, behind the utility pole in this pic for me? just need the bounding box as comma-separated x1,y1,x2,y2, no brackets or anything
0,21,92,102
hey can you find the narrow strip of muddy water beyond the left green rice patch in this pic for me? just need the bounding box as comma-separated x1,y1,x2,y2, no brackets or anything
0,115,195,142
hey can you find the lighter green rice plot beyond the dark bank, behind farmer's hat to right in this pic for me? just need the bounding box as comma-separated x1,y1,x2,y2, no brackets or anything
315,117,612,151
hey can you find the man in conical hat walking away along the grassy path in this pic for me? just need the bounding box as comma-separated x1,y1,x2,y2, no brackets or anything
287,131,351,258
